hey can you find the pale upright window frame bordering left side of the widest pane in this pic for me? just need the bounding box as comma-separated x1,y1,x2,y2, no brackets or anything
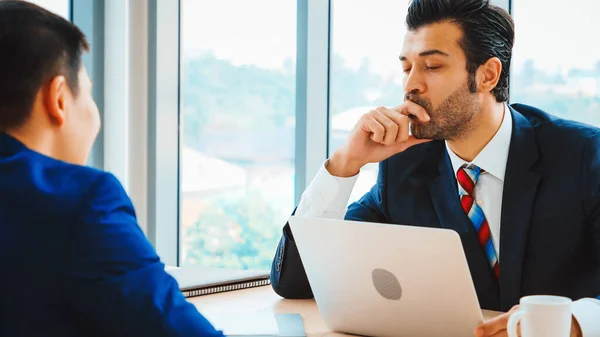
147,0,181,266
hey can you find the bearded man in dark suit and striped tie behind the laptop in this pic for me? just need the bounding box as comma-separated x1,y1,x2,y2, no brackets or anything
271,0,600,337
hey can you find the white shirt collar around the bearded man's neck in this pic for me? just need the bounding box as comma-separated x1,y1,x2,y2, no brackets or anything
446,104,512,181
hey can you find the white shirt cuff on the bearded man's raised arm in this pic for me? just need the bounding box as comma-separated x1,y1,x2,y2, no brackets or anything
295,161,358,219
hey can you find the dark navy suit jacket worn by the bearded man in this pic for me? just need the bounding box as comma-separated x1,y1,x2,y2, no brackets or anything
271,104,600,311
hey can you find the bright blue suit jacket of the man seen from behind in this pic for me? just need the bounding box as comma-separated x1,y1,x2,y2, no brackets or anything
0,133,222,337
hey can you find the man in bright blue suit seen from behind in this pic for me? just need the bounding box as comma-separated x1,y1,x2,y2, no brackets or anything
0,1,222,337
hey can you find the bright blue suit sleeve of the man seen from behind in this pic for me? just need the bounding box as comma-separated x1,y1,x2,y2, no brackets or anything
65,174,222,336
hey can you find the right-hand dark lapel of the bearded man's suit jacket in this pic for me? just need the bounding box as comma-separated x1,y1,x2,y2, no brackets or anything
500,108,540,310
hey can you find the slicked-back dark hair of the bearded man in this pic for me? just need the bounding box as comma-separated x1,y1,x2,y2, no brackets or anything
406,0,515,102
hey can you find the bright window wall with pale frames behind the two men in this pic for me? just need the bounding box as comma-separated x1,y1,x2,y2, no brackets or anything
31,0,600,270
